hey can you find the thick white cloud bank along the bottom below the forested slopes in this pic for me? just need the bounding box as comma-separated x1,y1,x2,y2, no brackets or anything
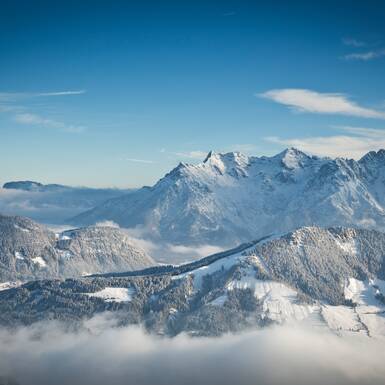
0,316,385,385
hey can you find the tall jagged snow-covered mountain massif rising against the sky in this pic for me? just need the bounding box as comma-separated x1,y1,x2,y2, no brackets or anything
72,148,385,246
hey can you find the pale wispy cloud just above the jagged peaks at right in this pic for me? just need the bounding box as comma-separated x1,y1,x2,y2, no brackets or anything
265,126,385,159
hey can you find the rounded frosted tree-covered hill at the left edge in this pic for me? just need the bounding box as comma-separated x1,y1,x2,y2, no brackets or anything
0,215,155,282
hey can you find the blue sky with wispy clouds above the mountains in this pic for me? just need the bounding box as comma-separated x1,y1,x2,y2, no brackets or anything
0,0,385,187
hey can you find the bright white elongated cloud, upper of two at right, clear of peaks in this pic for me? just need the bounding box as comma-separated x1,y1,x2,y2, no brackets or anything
257,88,385,119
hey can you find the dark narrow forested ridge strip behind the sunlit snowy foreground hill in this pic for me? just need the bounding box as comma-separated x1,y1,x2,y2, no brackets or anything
84,235,271,278
